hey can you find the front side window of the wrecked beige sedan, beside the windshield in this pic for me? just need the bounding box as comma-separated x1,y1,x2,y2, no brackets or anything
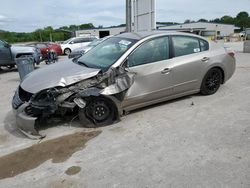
128,36,169,67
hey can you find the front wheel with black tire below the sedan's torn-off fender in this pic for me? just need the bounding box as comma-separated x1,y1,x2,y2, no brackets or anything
79,98,115,128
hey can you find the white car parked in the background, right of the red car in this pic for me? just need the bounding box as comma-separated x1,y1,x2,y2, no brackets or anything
61,37,97,55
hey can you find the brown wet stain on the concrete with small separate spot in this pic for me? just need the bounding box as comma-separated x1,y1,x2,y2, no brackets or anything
0,131,101,179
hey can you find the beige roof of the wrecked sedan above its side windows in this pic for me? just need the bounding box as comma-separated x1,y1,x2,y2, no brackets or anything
115,31,206,40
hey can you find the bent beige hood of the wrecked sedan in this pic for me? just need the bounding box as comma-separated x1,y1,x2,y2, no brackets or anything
21,61,100,93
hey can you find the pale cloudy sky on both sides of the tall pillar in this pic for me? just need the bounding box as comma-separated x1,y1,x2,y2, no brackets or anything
0,0,250,32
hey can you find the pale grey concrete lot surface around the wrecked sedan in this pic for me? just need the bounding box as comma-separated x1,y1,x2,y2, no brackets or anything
0,44,250,188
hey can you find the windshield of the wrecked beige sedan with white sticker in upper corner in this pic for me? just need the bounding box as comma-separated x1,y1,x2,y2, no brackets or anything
78,37,137,70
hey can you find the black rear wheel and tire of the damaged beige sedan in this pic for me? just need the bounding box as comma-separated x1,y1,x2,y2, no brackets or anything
201,68,222,95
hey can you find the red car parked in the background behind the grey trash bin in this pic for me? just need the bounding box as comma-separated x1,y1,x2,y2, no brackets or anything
27,42,63,59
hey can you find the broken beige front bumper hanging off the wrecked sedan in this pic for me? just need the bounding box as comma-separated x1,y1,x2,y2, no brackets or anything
13,103,45,139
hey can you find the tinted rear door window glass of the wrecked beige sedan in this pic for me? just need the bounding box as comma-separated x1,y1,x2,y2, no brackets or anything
172,36,201,57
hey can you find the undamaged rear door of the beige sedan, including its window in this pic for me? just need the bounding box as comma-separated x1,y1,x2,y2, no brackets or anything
171,35,209,94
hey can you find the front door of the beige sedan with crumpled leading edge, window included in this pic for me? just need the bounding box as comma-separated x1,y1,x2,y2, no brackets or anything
122,36,173,109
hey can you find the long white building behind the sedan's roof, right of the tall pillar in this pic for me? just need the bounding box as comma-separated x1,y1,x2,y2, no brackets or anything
158,22,239,37
